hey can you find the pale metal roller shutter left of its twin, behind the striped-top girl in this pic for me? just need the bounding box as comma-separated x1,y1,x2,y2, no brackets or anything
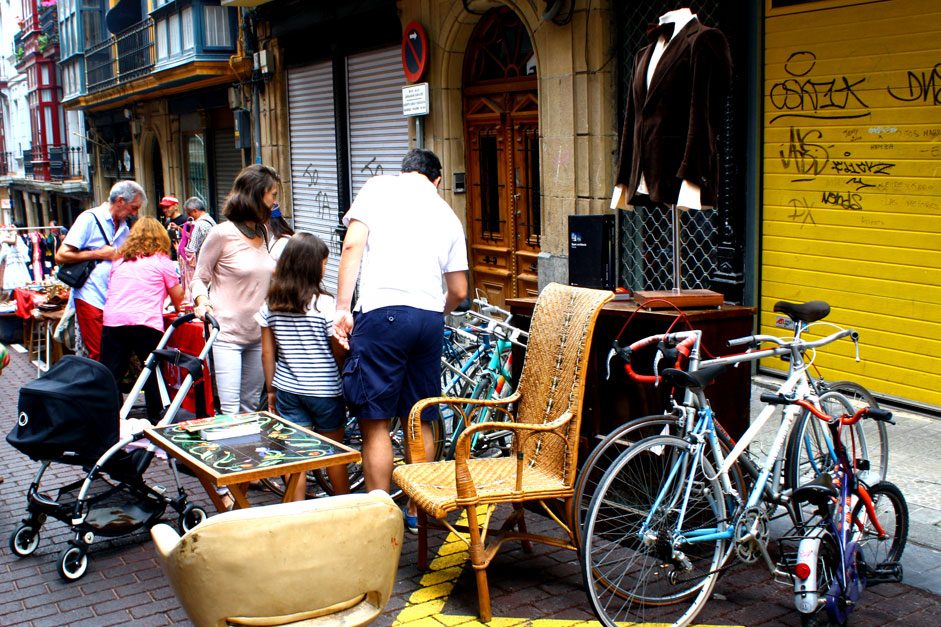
288,61,341,294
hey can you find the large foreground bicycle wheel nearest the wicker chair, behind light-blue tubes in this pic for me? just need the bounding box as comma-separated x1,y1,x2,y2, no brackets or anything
581,436,729,627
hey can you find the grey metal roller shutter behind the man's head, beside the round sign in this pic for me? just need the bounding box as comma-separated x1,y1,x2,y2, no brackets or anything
346,46,408,198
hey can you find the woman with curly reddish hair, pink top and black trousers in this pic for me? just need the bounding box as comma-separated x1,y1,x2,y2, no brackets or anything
101,217,183,424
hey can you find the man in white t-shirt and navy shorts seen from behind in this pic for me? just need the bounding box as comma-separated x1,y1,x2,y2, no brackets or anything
334,148,467,530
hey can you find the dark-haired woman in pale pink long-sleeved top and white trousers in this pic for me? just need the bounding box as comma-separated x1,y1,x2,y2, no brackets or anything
193,164,281,414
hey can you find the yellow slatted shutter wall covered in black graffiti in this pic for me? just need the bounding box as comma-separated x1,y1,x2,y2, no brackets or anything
760,0,941,405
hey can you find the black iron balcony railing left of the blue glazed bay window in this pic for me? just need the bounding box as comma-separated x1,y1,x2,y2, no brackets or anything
85,18,154,93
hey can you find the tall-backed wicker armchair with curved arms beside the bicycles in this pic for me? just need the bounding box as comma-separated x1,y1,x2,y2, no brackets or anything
394,283,613,622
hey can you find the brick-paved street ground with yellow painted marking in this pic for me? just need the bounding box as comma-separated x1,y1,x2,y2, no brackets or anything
0,351,941,627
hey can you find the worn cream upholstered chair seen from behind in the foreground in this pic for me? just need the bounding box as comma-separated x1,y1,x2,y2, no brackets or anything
150,490,404,627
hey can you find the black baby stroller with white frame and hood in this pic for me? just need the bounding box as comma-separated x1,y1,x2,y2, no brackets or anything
7,314,219,581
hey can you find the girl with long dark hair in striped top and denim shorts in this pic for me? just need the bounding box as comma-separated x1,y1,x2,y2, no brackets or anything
255,233,350,500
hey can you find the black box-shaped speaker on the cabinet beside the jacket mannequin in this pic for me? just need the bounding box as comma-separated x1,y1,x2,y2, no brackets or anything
569,215,616,290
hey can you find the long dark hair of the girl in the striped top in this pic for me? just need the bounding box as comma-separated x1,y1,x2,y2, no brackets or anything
268,233,330,313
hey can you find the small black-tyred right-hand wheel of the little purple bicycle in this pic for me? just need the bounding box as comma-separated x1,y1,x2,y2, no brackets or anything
853,481,909,568
